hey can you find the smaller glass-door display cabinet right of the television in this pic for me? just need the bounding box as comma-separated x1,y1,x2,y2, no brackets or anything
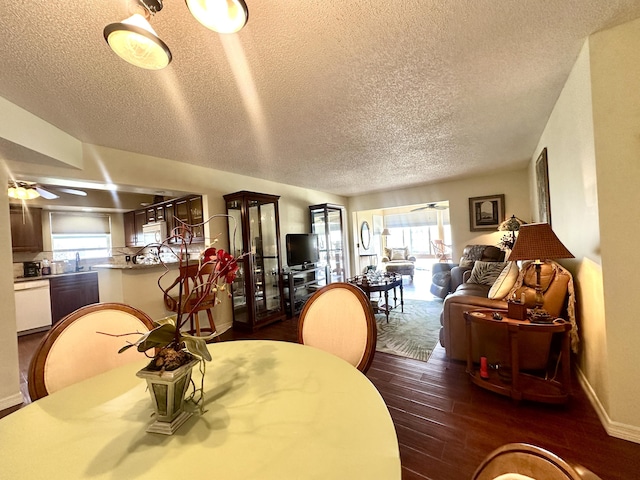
309,203,349,285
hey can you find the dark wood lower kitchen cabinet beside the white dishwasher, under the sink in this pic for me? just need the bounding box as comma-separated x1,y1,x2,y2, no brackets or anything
49,272,100,324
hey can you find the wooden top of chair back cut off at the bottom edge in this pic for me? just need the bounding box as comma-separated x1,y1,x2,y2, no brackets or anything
472,443,601,480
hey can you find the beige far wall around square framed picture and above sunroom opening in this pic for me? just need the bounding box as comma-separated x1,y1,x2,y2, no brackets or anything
349,168,531,259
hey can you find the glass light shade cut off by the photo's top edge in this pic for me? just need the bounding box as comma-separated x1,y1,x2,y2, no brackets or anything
186,0,249,33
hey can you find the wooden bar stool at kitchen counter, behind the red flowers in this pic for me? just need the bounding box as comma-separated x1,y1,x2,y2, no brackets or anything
164,263,218,339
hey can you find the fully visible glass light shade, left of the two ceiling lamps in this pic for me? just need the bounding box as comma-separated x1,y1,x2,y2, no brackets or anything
104,13,171,70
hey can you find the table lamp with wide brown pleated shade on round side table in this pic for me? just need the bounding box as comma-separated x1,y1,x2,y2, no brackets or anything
509,223,575,309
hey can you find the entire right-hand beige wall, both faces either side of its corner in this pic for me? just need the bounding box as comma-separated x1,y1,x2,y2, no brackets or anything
530,20,640,442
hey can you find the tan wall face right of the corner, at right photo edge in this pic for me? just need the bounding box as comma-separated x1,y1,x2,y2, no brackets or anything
590,19,640,434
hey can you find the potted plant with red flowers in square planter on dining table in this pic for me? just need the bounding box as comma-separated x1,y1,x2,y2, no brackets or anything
119,215,238,435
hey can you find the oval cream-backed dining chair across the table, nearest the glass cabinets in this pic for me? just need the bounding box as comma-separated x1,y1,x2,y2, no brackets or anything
298,282,377,373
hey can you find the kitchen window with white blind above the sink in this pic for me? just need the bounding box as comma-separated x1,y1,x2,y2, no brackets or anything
50,212,111,260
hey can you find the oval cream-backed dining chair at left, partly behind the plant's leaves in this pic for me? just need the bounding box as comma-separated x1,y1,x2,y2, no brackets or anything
28,303,154,400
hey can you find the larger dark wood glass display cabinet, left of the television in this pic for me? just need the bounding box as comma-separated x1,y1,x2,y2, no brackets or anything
224,191,286,331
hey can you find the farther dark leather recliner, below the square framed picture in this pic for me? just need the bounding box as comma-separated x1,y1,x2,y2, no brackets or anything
430,245,504,298
